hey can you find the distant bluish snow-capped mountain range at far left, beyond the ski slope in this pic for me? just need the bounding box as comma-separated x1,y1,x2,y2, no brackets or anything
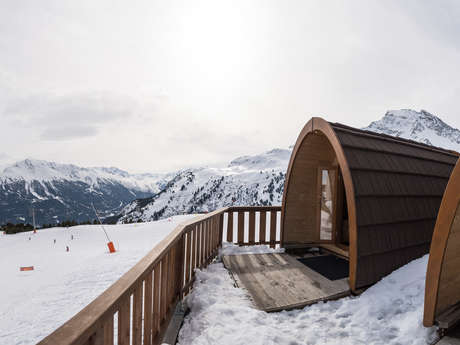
0,159,167,224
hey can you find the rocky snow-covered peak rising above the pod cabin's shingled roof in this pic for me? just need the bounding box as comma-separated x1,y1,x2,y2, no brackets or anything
363,109,460,152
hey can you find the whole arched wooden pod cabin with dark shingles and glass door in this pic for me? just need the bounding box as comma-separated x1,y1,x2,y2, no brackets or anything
281,117,458,291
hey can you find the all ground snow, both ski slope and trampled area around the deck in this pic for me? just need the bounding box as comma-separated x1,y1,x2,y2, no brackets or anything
0,220,436,345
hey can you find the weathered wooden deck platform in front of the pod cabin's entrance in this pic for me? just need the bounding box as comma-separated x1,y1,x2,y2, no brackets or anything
222,250,350,312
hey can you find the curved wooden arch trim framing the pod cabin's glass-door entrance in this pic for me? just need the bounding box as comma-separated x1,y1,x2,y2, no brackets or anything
281,117,358,291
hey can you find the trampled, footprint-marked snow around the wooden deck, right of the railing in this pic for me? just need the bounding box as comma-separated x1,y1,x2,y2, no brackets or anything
179,243,436,345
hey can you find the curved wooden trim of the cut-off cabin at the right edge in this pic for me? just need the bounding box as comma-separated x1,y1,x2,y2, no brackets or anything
423,161,460,327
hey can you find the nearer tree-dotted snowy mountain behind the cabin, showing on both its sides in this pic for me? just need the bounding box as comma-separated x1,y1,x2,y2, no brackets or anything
118,109,460,223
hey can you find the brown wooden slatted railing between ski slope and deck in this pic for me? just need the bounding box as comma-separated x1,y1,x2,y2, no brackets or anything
38,206,281,345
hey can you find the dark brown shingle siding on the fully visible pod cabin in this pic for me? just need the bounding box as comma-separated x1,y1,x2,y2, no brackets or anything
331,124,458,287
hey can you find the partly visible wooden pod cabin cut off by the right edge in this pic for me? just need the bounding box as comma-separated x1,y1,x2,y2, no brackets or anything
423,163,460,328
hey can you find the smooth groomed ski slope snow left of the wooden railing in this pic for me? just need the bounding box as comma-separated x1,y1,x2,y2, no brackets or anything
0,215,194,345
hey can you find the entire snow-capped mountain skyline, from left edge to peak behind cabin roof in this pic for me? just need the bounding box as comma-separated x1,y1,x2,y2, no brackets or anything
0,109,460,224
